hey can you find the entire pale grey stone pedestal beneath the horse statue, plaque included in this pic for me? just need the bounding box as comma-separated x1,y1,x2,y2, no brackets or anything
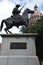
0,33,39,65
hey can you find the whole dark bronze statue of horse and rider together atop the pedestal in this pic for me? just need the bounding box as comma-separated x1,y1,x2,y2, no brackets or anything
0,4,33,34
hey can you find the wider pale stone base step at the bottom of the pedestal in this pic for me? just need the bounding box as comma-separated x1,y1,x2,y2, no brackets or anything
0,56,39,65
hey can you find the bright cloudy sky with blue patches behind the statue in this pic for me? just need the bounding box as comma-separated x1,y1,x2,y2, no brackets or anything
0,0,43,41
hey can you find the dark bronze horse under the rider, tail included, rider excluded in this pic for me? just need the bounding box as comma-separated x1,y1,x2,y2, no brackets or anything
0,8,33,34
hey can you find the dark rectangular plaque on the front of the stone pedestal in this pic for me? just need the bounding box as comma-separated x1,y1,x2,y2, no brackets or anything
10,42,27,49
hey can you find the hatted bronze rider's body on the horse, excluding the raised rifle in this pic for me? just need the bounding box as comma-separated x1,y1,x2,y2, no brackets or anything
12,4,21,22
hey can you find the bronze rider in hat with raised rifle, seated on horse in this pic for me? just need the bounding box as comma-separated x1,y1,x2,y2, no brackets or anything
12,3,26,23
